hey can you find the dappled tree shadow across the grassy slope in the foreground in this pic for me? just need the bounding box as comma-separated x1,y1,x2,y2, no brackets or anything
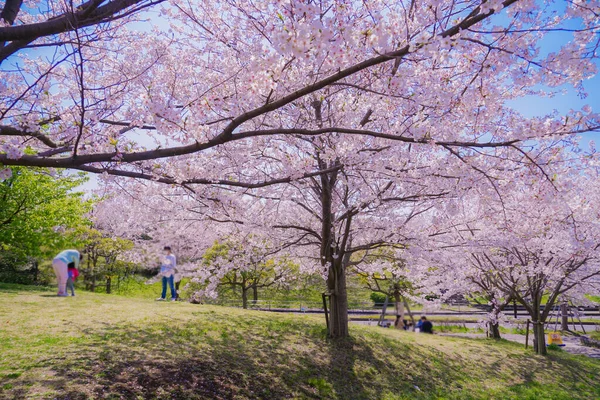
0,313,600,400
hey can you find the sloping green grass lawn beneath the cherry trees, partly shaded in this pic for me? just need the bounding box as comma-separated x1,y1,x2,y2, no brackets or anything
0,284,600,400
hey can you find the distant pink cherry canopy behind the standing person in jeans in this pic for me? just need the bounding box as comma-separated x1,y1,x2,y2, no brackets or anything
91,184,228,272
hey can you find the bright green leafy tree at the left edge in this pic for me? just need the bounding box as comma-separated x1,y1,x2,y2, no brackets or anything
0,167,92,283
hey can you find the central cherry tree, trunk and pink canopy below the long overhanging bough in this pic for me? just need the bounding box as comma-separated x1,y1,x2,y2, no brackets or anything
220,130,460,337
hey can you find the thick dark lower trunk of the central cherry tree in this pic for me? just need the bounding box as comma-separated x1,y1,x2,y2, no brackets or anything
327,262,348,338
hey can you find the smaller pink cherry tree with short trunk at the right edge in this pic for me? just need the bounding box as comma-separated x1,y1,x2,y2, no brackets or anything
413,148,600,354
